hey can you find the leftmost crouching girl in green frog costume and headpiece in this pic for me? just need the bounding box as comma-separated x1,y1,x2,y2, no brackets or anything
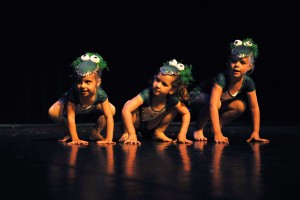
48,52,115,145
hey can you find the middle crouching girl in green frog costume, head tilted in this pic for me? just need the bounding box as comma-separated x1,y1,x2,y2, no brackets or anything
119,59,193,144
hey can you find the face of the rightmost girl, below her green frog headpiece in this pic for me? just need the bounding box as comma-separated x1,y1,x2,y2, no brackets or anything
230,56,253,77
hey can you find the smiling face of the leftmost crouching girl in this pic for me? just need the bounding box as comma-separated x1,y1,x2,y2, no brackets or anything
76,73,101,96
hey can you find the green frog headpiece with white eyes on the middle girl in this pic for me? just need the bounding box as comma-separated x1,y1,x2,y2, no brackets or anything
160,59,194,86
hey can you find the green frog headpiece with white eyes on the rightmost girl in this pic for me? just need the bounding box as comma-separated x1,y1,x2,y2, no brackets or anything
230,38,258,58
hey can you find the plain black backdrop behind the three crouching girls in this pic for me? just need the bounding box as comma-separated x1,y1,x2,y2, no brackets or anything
0,1,300,124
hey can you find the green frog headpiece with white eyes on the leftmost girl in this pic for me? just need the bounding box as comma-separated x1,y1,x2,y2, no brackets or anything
71,52,109,76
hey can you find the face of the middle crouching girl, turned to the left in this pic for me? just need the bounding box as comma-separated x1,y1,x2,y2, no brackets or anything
152,72,177,96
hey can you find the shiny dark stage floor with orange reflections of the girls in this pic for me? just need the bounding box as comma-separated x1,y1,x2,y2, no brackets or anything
0,122,300,200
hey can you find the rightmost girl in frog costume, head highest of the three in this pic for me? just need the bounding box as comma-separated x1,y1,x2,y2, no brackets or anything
189,38,269,143
